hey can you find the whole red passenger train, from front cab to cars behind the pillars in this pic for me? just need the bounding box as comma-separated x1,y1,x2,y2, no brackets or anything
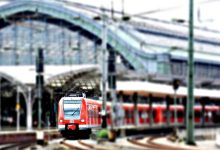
58,92,220,136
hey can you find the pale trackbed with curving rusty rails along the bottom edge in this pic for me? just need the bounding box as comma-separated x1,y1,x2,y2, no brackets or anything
61,136,209,150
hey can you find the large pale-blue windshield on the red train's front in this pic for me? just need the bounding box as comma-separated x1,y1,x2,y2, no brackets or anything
63,100,82,119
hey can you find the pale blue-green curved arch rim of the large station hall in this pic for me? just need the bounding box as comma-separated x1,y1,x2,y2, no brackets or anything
0,0,147,71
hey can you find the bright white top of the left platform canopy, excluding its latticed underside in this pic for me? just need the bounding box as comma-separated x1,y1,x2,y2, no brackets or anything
0,65,98,85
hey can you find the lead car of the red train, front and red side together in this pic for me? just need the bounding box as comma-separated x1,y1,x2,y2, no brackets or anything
58,96,101,136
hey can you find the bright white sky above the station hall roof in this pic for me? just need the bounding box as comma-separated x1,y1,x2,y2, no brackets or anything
70,0,220,30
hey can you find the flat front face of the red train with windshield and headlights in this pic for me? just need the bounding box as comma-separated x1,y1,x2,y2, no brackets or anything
58,97,86,136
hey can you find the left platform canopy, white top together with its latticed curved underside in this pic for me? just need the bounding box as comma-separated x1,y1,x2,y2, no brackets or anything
0,65,100,95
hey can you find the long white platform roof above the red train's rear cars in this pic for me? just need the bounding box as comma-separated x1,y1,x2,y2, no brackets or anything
117,81,220,99
